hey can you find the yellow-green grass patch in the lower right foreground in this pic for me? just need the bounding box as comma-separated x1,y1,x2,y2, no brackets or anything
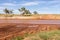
11,30,60,40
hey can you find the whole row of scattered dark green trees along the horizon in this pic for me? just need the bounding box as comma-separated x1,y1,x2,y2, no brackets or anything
0,7,39,16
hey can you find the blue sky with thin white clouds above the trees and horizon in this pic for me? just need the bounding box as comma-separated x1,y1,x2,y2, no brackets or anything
0,0,60,14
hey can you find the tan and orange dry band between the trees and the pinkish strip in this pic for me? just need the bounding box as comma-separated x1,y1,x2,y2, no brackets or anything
0,14,60,20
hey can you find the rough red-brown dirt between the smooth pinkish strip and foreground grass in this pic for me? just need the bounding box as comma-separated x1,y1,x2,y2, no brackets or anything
0,24,60,40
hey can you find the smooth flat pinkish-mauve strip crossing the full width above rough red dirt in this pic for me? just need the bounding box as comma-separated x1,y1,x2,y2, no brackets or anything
0,20,60,24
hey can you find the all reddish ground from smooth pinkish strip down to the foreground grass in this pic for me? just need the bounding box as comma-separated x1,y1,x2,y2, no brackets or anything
0,19,60,40
